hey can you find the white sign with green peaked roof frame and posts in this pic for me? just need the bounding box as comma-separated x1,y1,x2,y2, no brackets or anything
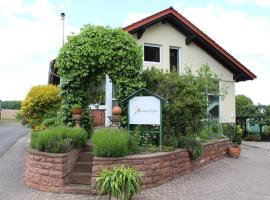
121,88,165,150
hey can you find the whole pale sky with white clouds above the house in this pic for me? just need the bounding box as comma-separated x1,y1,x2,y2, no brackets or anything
0,0,270,104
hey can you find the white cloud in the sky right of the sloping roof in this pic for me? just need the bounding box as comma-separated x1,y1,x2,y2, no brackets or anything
123,3,270,104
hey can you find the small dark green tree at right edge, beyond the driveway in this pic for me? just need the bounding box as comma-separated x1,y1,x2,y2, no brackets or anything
250,104,270,133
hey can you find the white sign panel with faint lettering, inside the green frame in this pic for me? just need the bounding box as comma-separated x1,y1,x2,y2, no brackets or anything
128,96,161,125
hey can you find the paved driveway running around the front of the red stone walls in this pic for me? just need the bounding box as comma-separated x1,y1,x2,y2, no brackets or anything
0,136,270,200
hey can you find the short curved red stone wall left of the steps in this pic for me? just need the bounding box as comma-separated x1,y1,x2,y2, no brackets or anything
25,149,80,192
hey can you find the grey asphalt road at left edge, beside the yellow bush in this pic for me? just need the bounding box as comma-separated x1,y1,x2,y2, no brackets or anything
0,122,29,157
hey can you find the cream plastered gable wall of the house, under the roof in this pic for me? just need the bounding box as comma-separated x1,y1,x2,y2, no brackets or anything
134,23,235,122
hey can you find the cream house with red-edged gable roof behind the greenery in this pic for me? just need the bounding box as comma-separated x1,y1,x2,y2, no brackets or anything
48,7,256,125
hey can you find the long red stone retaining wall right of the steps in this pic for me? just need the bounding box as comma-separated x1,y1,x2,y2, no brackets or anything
92,139,229,189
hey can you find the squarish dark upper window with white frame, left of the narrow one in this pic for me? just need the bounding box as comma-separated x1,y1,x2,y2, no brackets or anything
144,45,160,63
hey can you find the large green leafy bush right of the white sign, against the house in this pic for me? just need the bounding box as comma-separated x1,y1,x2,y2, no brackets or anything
142,65,226,137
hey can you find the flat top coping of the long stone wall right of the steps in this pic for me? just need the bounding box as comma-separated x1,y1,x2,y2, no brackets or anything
93,138,229,161
